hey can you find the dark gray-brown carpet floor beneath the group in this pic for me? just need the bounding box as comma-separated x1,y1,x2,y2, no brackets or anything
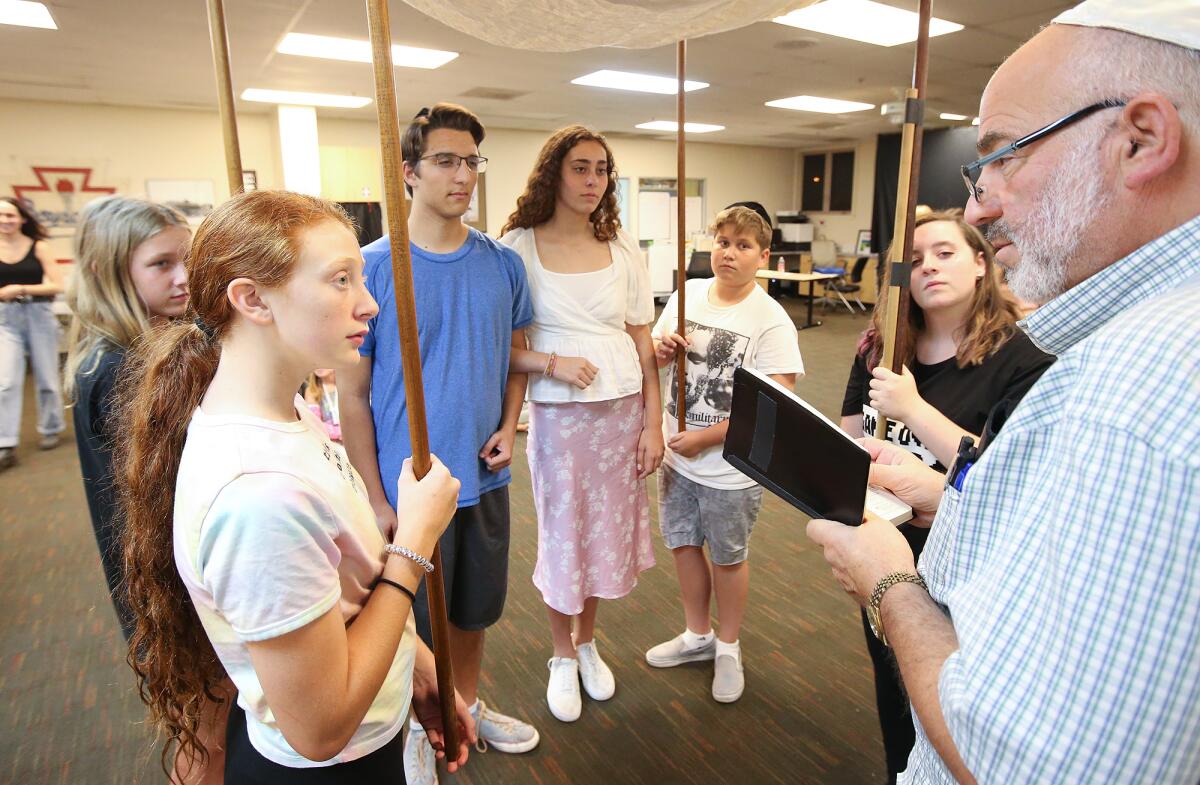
0,300,884,785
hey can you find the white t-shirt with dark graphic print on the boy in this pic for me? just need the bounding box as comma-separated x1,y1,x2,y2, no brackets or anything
653,278,804,490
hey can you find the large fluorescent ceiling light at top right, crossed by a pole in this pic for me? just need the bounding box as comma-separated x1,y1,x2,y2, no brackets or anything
774,0,962,47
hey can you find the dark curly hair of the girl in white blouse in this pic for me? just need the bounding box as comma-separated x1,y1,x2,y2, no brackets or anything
500,125,620,242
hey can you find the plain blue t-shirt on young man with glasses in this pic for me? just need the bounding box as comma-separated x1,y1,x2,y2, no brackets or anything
359,229,533,508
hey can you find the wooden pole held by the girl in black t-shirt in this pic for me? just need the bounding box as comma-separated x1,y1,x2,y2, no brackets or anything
875,0,932,439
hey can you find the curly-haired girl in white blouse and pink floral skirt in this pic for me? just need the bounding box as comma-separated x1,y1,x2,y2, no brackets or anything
500,126,664,723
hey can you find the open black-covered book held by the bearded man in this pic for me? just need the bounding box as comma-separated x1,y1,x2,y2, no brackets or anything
722,367,871,526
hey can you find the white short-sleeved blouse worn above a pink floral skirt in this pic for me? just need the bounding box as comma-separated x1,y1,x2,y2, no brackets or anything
500,224,654,403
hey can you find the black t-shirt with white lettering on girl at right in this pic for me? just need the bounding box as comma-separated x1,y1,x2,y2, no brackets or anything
841,330,1054,472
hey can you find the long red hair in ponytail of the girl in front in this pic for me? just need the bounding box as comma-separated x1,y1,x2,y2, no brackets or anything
113,191,354,775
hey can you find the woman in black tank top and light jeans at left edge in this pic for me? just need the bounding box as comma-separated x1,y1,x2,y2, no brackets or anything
0,197,66,471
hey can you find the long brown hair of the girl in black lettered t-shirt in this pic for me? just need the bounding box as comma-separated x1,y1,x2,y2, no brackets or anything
858,209,1021,368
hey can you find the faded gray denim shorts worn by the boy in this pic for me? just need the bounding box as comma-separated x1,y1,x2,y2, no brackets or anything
659,466,762,567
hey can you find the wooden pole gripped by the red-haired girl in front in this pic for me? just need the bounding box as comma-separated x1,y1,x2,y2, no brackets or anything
367,0,458,760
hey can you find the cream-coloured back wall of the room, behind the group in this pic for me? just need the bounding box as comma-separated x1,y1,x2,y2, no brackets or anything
0,101,875,256
